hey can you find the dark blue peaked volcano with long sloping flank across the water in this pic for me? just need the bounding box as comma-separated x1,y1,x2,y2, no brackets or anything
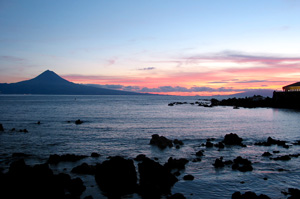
0,70,142,95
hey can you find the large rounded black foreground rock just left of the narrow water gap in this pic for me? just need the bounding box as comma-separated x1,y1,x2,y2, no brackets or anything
95,156,137,198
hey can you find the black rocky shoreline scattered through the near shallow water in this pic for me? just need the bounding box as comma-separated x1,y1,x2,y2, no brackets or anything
0,125,300,199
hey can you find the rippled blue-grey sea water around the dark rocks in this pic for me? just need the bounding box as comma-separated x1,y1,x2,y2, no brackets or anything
0,95,300,199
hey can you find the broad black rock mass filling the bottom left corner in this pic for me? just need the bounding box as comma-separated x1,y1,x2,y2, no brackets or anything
0,159,86,199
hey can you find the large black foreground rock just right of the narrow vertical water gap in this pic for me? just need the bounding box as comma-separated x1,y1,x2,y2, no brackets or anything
138,158,178,198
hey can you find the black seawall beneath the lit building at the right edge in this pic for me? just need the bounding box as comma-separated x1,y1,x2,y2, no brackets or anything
273,91,300,109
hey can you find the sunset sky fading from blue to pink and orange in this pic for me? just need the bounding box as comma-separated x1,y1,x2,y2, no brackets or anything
0,0,300,96
